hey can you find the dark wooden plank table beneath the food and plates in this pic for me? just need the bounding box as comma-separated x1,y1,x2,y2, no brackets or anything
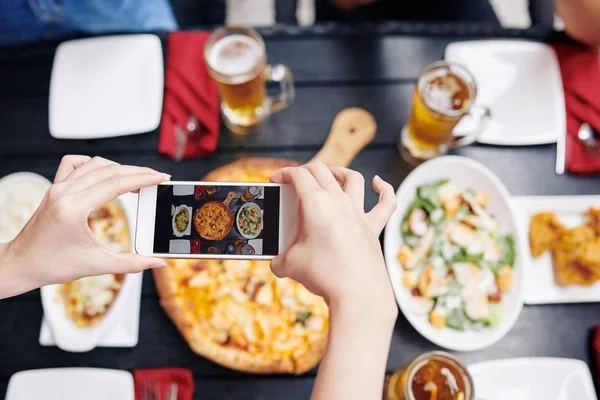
0,24,600,400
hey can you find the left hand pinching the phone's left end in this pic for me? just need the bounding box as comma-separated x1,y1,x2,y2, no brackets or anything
0,156,168,298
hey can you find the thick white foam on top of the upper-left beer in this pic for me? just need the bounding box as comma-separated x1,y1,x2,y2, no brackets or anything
207,35,263,76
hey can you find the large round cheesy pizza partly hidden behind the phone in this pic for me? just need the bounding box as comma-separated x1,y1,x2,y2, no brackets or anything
153,158,329,374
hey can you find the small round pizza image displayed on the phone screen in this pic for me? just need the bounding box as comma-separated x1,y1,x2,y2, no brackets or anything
194,201,233,240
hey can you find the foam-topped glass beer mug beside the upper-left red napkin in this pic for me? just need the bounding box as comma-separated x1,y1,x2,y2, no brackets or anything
204,27,294,134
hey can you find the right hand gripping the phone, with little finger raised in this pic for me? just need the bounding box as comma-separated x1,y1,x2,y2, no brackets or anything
271,163,397,318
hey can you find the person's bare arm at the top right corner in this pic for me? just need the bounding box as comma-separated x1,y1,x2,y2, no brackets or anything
554,0,600,46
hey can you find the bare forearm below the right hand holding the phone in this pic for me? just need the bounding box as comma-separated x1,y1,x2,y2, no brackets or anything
311,304,397,400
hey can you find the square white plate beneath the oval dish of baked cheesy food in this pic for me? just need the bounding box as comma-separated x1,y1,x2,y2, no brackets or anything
39,193,143,347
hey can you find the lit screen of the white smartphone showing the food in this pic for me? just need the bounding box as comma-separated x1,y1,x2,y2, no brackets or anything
154,184,280,256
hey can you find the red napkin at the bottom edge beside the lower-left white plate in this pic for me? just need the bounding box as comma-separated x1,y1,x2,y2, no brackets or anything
133,368,194,400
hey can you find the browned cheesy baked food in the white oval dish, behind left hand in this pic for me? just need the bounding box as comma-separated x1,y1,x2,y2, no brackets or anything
57,202,131,328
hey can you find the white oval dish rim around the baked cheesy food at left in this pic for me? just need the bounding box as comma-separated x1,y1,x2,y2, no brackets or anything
41,199,134,353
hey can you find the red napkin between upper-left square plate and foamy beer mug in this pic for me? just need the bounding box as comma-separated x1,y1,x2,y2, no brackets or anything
158,32,220,158
